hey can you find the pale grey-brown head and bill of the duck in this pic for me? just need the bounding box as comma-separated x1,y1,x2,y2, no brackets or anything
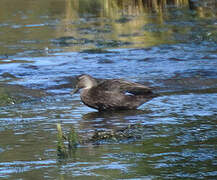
71,74,97,94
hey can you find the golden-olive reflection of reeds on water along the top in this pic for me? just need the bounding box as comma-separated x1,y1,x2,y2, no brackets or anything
0,0,216,56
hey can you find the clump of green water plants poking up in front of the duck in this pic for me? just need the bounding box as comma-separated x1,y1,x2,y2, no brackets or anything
57,123,159,158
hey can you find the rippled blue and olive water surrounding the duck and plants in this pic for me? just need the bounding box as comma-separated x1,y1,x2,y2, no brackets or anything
0,0,217,179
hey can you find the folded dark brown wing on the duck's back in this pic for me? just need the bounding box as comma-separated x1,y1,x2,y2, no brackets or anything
97,79,152,95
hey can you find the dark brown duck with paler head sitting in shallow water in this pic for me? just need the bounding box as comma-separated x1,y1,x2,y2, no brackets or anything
71,74,158,111
